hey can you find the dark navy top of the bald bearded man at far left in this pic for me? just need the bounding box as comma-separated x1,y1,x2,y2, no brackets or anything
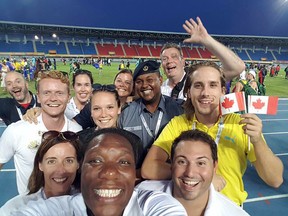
0,92,40,126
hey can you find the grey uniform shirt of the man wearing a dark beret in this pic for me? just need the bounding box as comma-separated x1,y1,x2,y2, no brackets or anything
118,96,183,150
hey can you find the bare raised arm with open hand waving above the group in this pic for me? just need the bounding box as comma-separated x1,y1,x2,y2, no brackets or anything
183,17,245,80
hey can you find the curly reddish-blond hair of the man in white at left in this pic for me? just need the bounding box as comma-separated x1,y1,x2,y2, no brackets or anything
36,70,70,93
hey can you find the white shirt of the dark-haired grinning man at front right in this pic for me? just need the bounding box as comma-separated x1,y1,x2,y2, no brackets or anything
136,181,249,216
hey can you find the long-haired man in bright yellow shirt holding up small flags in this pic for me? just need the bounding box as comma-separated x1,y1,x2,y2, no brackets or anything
141,62,283,205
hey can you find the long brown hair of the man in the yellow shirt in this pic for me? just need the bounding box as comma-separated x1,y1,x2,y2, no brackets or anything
183,61,226,120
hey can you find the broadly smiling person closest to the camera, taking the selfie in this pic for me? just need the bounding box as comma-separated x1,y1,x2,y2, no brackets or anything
14,128,187,216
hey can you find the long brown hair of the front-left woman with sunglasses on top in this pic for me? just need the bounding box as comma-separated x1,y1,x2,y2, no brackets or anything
28,132,83,194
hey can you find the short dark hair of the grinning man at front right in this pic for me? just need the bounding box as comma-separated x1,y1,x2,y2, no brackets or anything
171,129,218,163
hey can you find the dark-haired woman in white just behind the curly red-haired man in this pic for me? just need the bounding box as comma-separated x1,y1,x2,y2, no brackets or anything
65,69,93,119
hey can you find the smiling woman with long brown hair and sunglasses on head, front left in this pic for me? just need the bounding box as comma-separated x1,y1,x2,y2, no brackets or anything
0,131,82,215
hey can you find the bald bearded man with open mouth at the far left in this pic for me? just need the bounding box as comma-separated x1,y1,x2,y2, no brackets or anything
0,71,38,126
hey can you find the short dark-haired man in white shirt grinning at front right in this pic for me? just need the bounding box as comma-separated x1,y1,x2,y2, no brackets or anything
137,130,248,216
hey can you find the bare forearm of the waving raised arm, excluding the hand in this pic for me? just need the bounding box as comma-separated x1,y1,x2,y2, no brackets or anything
202,35,245,80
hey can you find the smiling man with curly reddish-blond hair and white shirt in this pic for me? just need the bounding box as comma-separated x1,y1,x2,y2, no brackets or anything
0,71,82,194
